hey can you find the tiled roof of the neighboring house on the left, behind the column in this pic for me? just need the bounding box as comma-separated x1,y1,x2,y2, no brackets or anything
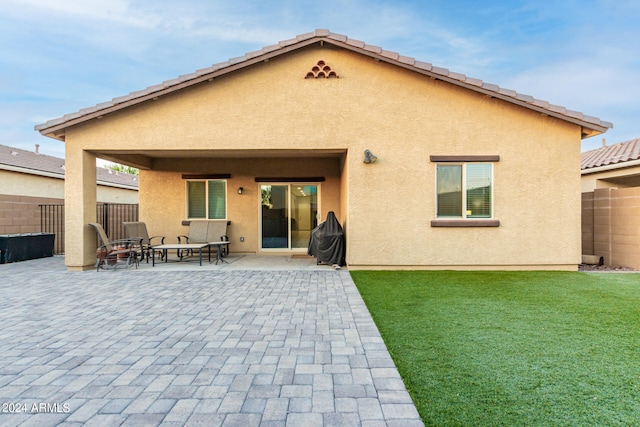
0,145,138,190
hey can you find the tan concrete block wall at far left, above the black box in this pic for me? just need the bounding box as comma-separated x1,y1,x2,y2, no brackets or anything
0,194,64,234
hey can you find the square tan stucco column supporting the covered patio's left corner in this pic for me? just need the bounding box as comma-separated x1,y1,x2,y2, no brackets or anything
64,147,96,271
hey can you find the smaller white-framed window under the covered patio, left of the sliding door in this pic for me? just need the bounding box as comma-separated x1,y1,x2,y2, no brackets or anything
187,179,227,219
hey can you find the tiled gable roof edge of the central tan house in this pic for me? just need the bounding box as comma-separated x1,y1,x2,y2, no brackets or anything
35,30,613,141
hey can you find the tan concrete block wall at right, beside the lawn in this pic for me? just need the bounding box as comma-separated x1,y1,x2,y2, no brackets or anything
582,187,640,269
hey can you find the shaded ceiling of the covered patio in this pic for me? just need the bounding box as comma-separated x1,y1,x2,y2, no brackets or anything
91,148,347,169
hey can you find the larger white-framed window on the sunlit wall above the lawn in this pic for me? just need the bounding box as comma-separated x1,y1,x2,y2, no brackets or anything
436,162,493,219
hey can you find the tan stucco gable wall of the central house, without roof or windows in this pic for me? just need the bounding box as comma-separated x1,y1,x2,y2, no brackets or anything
66,47,581,269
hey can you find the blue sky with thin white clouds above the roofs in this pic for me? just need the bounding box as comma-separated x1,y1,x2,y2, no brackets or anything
0,0,640,157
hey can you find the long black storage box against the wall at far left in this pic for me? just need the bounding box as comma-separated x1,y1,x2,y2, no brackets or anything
0,233,56,264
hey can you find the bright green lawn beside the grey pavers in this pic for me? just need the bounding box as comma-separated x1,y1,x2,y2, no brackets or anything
351,271,640,426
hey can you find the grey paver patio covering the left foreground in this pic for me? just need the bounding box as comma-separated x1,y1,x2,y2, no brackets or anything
0,257,423,427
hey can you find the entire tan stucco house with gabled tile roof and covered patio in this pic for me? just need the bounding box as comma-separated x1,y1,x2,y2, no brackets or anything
36,30,612,270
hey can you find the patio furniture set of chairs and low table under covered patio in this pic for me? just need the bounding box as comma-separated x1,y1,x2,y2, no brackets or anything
89,220,230,271
